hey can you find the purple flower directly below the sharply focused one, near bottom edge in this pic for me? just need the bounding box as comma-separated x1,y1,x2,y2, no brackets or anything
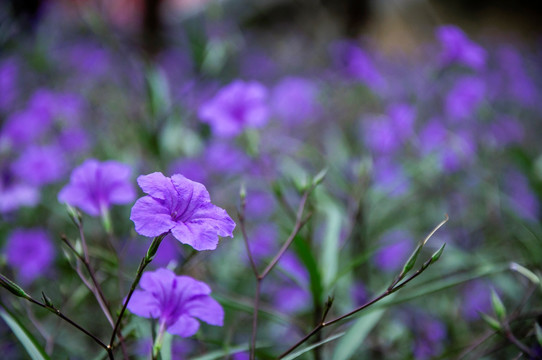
128,269,224,337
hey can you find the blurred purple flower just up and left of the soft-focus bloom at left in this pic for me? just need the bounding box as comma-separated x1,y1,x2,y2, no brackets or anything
12,146,67,186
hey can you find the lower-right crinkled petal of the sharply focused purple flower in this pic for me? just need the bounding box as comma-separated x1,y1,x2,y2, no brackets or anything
171,220,218,251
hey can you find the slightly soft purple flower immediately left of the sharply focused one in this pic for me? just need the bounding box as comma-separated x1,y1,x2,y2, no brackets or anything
58,159,135,216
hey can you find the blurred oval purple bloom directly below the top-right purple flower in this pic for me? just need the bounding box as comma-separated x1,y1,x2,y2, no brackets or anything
446,76,486,120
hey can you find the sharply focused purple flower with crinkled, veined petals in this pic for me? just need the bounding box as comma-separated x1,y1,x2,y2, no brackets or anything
130,172,235,250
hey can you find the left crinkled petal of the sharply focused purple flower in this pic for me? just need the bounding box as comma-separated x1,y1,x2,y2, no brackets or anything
130,196,175,237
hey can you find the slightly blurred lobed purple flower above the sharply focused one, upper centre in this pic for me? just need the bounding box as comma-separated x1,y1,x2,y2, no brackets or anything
199,80,269,137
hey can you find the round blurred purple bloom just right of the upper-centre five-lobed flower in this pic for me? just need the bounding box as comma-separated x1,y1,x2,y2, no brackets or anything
271,76,319,124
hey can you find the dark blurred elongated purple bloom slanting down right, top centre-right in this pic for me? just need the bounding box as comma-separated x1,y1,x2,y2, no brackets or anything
331,41,383,90
